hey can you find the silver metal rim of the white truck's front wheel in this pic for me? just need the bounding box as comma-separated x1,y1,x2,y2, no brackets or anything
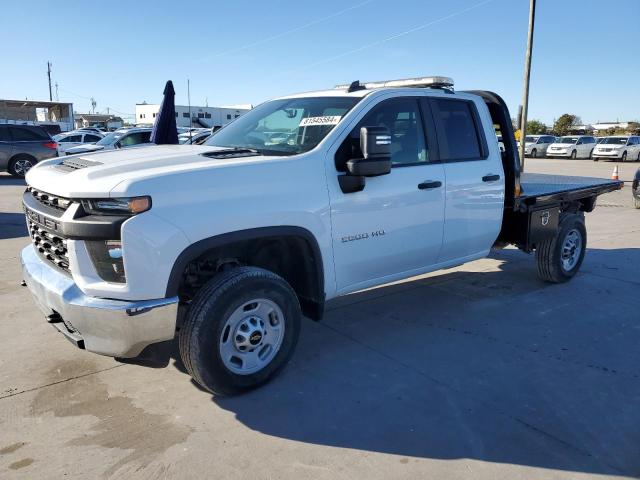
219,298,285,375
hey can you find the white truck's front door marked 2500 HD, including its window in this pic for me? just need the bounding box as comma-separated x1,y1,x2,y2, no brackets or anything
328,97,445,293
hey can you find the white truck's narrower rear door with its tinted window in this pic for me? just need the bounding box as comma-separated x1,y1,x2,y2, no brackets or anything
428,95,504,263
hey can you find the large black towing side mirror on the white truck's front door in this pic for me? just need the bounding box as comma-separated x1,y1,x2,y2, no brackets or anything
347,127,391,177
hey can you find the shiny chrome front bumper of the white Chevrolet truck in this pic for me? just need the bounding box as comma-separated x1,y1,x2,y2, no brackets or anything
21,245,178,357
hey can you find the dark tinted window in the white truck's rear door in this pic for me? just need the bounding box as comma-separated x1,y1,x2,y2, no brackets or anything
431,98,483,162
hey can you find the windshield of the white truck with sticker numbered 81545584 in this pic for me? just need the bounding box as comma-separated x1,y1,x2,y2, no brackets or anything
204,97,360,155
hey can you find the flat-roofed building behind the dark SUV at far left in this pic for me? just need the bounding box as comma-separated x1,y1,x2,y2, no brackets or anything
0,100,74,133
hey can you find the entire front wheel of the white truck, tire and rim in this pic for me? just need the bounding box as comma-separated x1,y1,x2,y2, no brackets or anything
179,267,302,395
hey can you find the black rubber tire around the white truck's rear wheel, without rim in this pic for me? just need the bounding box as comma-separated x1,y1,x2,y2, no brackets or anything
536,213,587,283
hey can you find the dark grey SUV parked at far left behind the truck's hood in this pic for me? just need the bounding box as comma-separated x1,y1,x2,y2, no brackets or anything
0,123,58,178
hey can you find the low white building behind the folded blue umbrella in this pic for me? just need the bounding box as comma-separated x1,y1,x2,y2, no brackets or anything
136,102,252,128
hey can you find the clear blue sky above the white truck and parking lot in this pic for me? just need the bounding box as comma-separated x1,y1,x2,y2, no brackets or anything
0,0,640,123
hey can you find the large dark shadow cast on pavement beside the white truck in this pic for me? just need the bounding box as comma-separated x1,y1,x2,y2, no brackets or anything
129,249,640,475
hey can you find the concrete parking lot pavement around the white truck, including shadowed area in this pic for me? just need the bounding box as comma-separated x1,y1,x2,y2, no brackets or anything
0,159,640,480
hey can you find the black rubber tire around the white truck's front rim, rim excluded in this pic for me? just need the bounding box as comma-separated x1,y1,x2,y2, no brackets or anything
179,267,302,395
